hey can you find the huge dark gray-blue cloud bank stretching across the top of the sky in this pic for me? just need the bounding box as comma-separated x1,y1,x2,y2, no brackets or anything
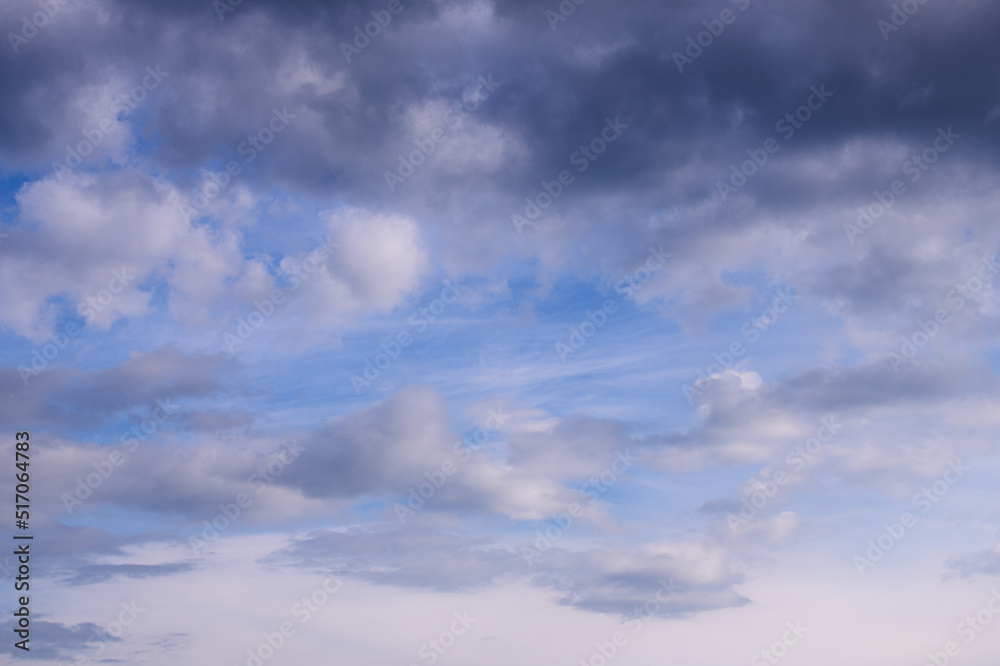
0,0,1000,342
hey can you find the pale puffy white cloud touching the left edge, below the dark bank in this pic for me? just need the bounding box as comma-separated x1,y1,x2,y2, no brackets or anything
0,171,268,341
